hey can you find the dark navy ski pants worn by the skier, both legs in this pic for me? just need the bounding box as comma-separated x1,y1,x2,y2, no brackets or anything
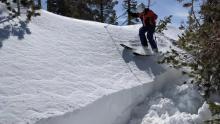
139,26,157,49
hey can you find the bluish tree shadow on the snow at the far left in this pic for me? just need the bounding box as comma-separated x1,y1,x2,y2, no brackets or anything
0,19,31,48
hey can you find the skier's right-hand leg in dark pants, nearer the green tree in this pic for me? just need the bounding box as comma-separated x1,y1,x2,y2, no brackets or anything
147,27,158,50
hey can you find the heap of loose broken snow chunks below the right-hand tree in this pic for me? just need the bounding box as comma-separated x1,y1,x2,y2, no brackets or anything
129,84,211,124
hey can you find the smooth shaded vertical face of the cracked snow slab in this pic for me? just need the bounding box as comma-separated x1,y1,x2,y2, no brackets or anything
36,69,183,124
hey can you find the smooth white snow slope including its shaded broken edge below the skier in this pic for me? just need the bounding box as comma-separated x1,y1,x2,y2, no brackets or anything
0,10,211,124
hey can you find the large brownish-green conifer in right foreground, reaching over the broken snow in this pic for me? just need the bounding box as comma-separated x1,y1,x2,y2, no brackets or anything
162,0,220,99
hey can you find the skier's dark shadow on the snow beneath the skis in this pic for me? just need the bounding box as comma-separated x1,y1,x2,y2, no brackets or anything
122,49,166,76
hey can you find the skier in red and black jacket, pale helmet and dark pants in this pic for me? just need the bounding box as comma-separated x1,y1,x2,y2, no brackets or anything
127,3,158,54
